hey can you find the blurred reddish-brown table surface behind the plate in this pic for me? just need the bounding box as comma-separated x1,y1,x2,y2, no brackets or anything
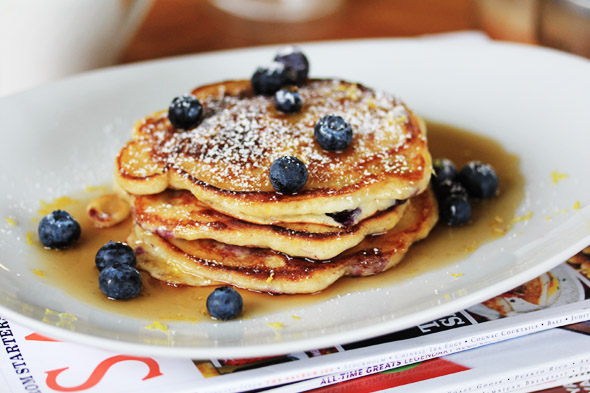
121,0,478,63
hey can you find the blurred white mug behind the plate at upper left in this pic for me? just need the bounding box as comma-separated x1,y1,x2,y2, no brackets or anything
0,0,152,96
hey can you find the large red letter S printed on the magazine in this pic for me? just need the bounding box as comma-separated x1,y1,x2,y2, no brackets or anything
45,355,162,392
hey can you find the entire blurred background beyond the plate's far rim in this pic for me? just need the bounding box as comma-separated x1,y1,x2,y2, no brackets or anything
0,0,590,96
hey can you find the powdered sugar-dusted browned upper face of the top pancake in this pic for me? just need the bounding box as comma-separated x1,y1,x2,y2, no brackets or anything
139,80,420,191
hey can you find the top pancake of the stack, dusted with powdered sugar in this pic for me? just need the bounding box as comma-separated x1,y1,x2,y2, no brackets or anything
115,80,432,227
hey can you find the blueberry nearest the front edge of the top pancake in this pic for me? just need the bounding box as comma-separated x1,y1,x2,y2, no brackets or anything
269,156,308,194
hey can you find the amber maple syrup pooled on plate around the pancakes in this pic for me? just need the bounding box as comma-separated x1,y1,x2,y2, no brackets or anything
35,123,524,323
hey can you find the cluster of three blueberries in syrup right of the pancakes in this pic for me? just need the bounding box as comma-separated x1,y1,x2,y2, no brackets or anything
432,158,498,226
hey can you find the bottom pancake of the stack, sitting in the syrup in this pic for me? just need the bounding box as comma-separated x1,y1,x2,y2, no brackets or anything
128,189,438,294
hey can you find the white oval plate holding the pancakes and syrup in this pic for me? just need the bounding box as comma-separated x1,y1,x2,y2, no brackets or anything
0,39,590,358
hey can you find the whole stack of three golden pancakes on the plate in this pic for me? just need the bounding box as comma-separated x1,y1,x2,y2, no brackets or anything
115,80,438,293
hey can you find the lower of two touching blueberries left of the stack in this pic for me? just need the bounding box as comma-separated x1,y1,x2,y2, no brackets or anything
98,263,142,300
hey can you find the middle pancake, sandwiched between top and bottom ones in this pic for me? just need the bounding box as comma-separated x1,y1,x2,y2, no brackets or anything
133,190,408,259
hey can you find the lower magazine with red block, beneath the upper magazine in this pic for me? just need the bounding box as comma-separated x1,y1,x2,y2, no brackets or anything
288,322,590,393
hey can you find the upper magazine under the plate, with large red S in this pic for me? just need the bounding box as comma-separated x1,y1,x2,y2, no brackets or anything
0,248,590,393
